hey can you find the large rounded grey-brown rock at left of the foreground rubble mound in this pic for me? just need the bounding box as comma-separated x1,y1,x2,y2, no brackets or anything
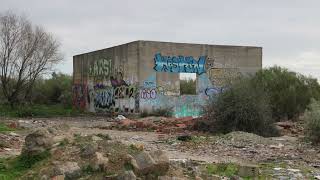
22,129,53,155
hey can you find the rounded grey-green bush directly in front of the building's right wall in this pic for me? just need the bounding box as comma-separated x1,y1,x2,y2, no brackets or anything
204,78,278,136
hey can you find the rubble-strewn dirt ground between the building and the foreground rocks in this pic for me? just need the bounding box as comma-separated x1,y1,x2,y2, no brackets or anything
0,117,320,179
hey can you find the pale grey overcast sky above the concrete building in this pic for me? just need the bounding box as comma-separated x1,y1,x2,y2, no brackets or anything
0,0,320,79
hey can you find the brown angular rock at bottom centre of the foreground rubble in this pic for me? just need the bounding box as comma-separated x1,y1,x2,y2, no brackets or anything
131,151,169,175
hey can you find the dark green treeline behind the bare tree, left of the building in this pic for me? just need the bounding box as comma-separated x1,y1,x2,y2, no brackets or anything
0,73,75,117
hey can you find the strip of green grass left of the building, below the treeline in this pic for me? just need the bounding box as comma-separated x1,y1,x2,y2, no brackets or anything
0,104,84,117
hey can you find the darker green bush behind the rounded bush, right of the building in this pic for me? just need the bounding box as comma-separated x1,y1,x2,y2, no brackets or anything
252,66,320,121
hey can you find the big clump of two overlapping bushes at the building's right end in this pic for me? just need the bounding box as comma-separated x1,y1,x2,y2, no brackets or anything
199,66,320,136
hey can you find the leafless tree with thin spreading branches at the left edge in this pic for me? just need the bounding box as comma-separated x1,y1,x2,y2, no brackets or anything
0,12,62,105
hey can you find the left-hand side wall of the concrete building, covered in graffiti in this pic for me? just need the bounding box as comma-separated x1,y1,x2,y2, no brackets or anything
73,42,139,112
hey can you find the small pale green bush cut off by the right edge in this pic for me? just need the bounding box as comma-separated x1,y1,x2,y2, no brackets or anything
304,99,320,144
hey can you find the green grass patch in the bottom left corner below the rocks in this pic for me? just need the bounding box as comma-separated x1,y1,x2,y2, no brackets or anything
0,151,51,180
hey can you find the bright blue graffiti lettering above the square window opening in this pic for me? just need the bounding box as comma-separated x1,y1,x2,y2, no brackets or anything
154,53,207,75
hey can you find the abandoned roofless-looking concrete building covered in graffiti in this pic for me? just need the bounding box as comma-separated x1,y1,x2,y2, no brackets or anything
73,41,262,117
